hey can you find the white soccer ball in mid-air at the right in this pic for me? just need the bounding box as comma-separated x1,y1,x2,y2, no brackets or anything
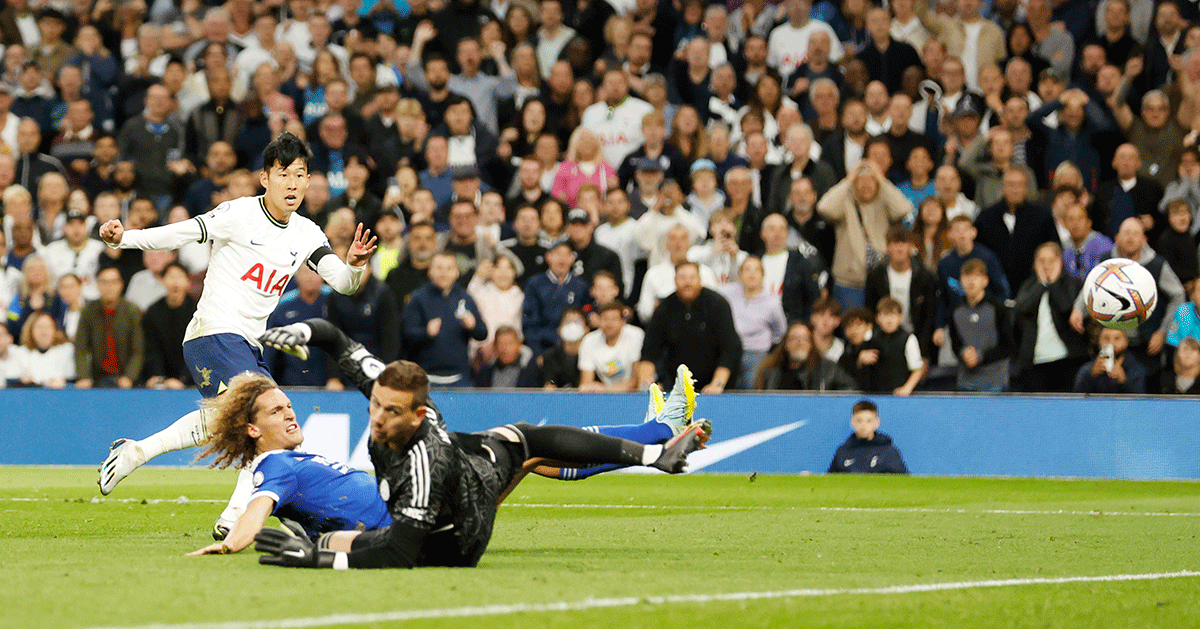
1084,258,1158,330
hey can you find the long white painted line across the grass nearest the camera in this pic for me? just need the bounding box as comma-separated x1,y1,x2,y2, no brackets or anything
79,570,1200,629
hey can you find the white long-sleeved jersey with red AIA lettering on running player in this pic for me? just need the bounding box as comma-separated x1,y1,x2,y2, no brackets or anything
120,197,366,347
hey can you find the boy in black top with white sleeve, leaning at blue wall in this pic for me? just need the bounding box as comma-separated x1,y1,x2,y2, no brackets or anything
859,296,925,396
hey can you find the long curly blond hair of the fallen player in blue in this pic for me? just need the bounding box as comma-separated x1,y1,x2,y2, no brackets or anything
196,371,278,469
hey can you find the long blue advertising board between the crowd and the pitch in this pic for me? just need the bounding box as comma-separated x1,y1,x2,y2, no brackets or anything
0,389,1200,479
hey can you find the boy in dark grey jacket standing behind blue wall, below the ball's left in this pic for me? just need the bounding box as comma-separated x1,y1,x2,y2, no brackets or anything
947,258,1013,391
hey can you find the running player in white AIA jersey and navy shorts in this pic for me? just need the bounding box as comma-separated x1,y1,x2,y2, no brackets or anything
98,133,376,528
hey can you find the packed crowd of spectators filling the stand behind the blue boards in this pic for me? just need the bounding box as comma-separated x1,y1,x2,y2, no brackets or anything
0,0,1200,395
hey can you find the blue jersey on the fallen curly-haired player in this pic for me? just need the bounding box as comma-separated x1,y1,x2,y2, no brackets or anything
250,450,391,537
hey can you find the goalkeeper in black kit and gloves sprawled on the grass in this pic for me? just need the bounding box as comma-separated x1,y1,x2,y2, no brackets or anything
254,319,709,569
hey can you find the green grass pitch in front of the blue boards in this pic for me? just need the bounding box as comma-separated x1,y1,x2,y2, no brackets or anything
0,467,1200,629
